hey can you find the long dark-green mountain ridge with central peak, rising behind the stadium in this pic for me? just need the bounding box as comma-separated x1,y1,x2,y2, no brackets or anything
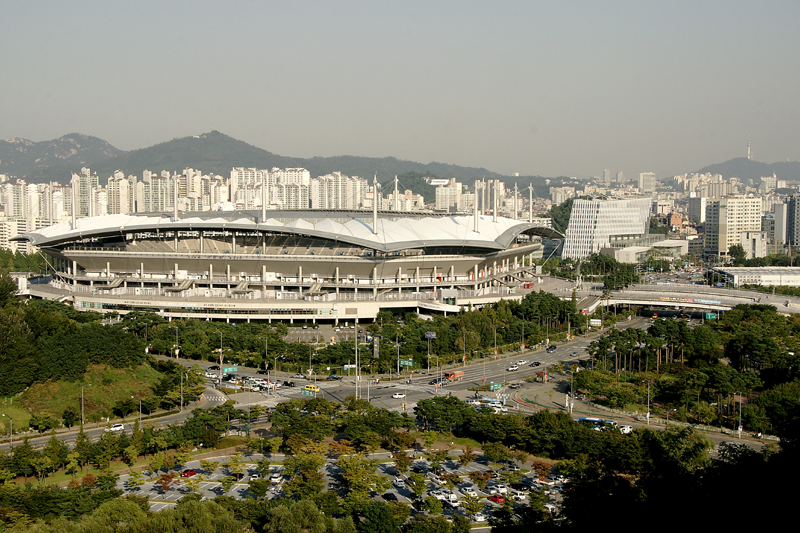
17,131,502,183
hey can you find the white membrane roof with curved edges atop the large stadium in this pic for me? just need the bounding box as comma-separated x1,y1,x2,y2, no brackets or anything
17,211,562,252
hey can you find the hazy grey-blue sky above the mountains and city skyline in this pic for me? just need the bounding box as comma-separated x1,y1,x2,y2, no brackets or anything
0,0,800,179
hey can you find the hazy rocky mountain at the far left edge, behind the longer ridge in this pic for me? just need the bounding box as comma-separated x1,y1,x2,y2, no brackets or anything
0,133,124,181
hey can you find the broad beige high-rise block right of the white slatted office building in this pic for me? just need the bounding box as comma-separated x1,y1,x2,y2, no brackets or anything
704,197,761,256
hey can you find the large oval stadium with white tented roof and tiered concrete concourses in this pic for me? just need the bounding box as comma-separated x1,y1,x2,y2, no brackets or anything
17,210,562,323
